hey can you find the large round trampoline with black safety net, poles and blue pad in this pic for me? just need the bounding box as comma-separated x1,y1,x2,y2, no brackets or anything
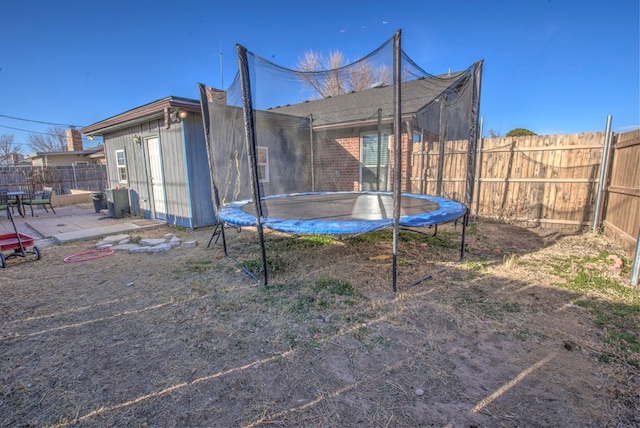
199,31,482,290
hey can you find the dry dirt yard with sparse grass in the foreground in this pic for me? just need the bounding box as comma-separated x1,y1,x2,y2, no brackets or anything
0,222,640,427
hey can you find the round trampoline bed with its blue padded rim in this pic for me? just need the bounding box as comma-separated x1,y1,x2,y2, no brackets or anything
218,191,467,235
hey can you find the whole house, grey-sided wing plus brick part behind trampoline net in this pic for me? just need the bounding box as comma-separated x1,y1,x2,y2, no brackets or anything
80,58,480,228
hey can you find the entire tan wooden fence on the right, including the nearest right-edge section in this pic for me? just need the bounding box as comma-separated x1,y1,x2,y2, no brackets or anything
411,131,640,251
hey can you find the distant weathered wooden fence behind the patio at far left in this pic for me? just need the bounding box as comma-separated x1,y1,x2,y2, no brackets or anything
0,165,107,195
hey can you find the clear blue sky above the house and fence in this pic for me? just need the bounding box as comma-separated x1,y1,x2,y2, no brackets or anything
0,0,640,154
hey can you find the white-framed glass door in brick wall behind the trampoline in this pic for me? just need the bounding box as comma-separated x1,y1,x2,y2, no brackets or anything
360,132,389,191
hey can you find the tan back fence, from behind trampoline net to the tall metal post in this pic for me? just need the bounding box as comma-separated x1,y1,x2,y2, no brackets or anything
412,133,604,227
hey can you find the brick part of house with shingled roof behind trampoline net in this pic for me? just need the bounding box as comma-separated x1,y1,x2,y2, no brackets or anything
269,72,469,191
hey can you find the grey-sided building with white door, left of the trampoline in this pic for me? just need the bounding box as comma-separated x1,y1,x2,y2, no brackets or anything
80,96,215,229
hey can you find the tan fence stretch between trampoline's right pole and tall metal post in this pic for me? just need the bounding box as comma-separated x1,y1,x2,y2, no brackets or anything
471,133,604,228
